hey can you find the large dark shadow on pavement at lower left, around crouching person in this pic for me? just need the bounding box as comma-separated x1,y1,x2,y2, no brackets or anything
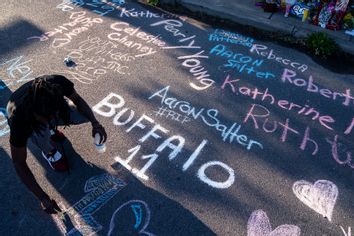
0,133,215,235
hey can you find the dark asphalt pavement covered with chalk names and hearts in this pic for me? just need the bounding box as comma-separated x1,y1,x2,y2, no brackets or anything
0,0,354,236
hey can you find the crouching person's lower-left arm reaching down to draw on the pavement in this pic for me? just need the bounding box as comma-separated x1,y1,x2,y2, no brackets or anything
11,145,61,214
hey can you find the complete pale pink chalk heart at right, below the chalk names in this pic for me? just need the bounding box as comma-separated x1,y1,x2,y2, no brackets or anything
293,180,338,221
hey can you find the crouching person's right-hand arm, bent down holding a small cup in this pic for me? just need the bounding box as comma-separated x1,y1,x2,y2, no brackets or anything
67,90,107,143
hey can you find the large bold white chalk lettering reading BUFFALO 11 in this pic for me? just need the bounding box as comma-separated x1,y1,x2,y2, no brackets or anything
92,93,242,189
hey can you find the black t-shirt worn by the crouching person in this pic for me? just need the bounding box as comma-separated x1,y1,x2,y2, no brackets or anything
7,75,74,147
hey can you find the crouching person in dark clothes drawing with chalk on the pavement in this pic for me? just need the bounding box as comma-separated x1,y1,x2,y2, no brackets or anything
6,75,107,214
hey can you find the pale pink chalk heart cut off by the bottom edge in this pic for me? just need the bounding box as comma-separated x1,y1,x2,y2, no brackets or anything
247,210,301,236
